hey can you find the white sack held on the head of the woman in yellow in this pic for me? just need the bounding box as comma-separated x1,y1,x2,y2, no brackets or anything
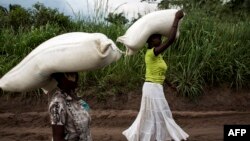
116,9,183,55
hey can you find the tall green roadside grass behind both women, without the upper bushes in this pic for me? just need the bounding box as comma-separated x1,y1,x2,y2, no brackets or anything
0,6,250,98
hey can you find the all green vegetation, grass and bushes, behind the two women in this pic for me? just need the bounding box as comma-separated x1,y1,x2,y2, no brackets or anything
0,0,250,99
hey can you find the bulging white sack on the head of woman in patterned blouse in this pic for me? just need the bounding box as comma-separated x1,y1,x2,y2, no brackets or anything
0,32,121,92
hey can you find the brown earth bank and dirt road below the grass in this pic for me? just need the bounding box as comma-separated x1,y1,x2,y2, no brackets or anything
0,87,250,141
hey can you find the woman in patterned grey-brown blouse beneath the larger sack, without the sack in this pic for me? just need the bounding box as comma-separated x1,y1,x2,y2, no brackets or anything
48,72,92,141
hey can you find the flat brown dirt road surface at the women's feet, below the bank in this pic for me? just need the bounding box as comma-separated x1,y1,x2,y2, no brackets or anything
0,110,250,141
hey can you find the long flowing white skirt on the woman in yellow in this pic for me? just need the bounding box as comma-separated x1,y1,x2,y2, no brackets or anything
122,82,189,141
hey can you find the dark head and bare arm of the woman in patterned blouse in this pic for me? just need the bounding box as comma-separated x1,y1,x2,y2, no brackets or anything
52,73,78,141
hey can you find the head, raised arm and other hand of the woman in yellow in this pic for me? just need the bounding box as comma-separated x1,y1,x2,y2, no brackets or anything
148,10,184,91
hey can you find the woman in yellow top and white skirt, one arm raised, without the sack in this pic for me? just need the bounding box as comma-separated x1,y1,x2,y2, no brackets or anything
123,10,188,141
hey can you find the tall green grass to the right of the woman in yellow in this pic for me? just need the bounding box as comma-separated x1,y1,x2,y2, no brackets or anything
168,11,250,97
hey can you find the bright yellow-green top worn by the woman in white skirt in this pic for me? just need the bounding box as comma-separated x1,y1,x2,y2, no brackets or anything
145,48,167,84
